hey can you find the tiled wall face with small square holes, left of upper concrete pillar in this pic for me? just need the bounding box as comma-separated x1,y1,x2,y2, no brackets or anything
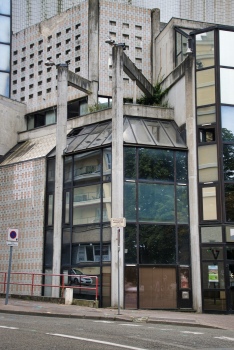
11,2,88,113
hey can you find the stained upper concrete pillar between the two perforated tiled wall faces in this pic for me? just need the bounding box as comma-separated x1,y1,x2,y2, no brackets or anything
88,0,99,105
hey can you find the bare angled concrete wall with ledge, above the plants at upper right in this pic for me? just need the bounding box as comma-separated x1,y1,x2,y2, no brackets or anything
155,18,215,80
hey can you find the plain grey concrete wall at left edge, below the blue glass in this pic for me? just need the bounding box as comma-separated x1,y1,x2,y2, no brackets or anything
0,95,26,156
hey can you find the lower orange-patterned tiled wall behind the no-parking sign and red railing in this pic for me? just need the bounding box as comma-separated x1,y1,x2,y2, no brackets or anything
0,158,46,295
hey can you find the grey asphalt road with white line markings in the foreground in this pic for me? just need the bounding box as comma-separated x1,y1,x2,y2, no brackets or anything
0,313,234,350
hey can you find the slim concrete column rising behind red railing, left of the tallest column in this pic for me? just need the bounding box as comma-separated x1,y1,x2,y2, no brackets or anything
52,64,68,298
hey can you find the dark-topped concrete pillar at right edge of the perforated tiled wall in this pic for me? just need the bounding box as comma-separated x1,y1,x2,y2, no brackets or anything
151,9,160,86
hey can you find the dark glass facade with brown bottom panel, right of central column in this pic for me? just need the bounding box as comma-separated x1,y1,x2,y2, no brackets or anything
124,147,192,309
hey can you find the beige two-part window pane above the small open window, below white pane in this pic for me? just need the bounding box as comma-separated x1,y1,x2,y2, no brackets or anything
196,68,215,106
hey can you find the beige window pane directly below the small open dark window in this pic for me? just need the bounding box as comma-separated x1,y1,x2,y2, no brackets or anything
198,145,218,182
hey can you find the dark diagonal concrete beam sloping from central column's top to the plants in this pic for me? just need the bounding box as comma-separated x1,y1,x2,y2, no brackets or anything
123,53,154,97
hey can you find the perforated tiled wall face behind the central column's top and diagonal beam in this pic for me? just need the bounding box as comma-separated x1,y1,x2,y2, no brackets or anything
99,0,151,98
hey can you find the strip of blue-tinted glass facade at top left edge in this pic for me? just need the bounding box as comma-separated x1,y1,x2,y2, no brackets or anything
0,0,11,97
